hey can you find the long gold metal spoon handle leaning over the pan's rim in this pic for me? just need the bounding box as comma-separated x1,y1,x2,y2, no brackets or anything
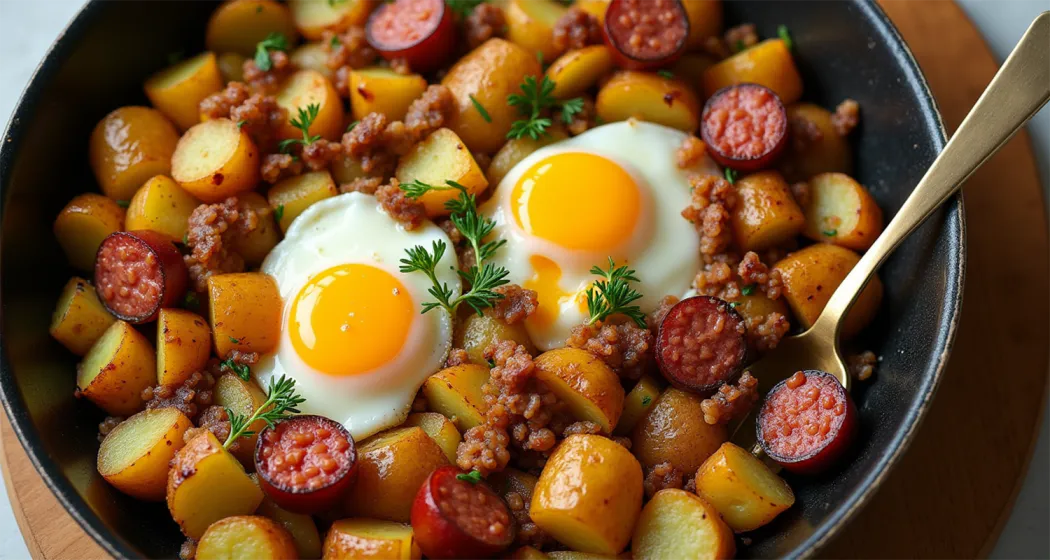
813,12,1050,339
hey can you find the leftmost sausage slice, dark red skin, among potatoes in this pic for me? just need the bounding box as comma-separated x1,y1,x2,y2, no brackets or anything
95,229,189,325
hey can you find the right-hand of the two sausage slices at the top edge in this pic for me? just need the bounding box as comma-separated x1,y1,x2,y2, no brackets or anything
603,0,689,70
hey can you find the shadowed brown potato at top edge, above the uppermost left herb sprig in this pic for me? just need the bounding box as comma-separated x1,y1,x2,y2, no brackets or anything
204,0,298,57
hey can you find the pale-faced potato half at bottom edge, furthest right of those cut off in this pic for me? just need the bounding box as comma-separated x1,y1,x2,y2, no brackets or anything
631,489,736,560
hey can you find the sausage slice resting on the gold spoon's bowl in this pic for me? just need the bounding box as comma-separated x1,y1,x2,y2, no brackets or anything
756,370,857,475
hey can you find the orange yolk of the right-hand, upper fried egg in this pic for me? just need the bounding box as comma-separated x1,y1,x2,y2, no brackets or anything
510,151,642,251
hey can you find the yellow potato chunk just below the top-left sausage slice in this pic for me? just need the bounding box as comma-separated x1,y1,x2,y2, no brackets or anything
350,67,426,121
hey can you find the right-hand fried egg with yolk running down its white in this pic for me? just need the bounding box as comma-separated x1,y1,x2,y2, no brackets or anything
481,120,721,350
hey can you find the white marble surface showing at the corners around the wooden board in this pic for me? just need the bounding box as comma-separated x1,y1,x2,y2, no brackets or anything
0,0,1050,560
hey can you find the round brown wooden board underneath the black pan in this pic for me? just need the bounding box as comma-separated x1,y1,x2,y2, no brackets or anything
0,0,1050,560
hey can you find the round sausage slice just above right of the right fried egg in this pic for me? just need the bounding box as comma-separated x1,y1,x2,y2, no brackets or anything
700,84,788,171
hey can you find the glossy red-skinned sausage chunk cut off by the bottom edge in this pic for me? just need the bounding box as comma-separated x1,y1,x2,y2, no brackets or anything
412,465,515,560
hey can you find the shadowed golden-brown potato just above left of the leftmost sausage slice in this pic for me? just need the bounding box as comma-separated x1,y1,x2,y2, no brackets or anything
55,192,124,270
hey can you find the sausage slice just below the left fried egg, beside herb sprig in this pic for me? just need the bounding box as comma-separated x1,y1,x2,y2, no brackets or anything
255,415,357,514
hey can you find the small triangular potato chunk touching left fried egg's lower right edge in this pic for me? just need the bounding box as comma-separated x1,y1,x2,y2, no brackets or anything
423,364,488,433
